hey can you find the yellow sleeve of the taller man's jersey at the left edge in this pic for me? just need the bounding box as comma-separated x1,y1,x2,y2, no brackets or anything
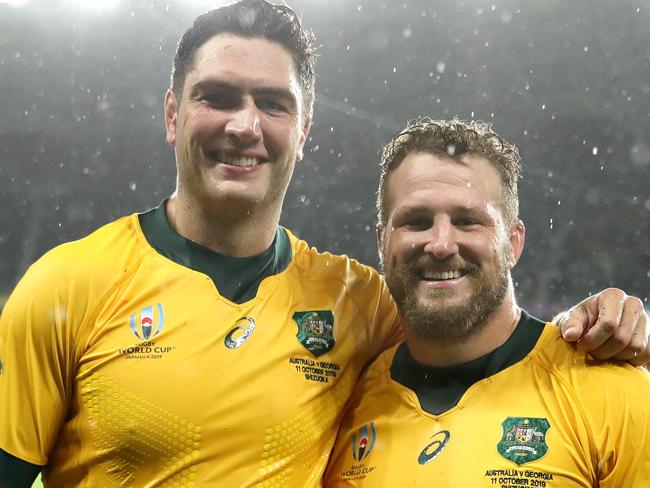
0,255,79,466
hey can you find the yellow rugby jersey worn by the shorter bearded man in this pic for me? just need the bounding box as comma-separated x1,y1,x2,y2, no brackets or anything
325,313,650,488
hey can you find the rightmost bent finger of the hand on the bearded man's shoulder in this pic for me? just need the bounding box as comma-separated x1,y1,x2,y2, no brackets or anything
590,297,645,361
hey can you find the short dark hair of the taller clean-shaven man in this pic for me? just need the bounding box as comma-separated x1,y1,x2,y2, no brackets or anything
171,0,316,115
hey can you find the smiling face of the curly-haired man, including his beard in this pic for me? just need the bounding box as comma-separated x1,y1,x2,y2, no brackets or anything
378,153,524,341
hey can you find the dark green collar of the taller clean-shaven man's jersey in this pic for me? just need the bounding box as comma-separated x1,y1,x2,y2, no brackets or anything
138,200,291,303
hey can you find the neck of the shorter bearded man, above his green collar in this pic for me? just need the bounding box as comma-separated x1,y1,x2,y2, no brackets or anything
403,285,521,367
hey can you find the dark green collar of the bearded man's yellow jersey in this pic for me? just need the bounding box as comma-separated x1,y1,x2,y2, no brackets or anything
390,310,545,415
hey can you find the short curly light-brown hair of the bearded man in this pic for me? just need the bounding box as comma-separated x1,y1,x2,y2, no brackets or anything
377,117,521,225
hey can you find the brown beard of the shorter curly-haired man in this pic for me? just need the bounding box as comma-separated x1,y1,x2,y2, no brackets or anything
385,244,510,342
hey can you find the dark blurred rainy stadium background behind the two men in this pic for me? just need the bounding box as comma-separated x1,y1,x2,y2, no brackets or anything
0,0,650,317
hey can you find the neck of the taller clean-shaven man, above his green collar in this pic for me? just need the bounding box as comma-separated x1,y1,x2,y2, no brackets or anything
166,192,280,257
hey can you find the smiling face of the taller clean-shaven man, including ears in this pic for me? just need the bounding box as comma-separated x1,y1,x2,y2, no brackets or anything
165,34,310,212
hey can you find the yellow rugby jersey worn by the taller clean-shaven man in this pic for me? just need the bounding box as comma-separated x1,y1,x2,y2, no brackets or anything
0,208,399,488
